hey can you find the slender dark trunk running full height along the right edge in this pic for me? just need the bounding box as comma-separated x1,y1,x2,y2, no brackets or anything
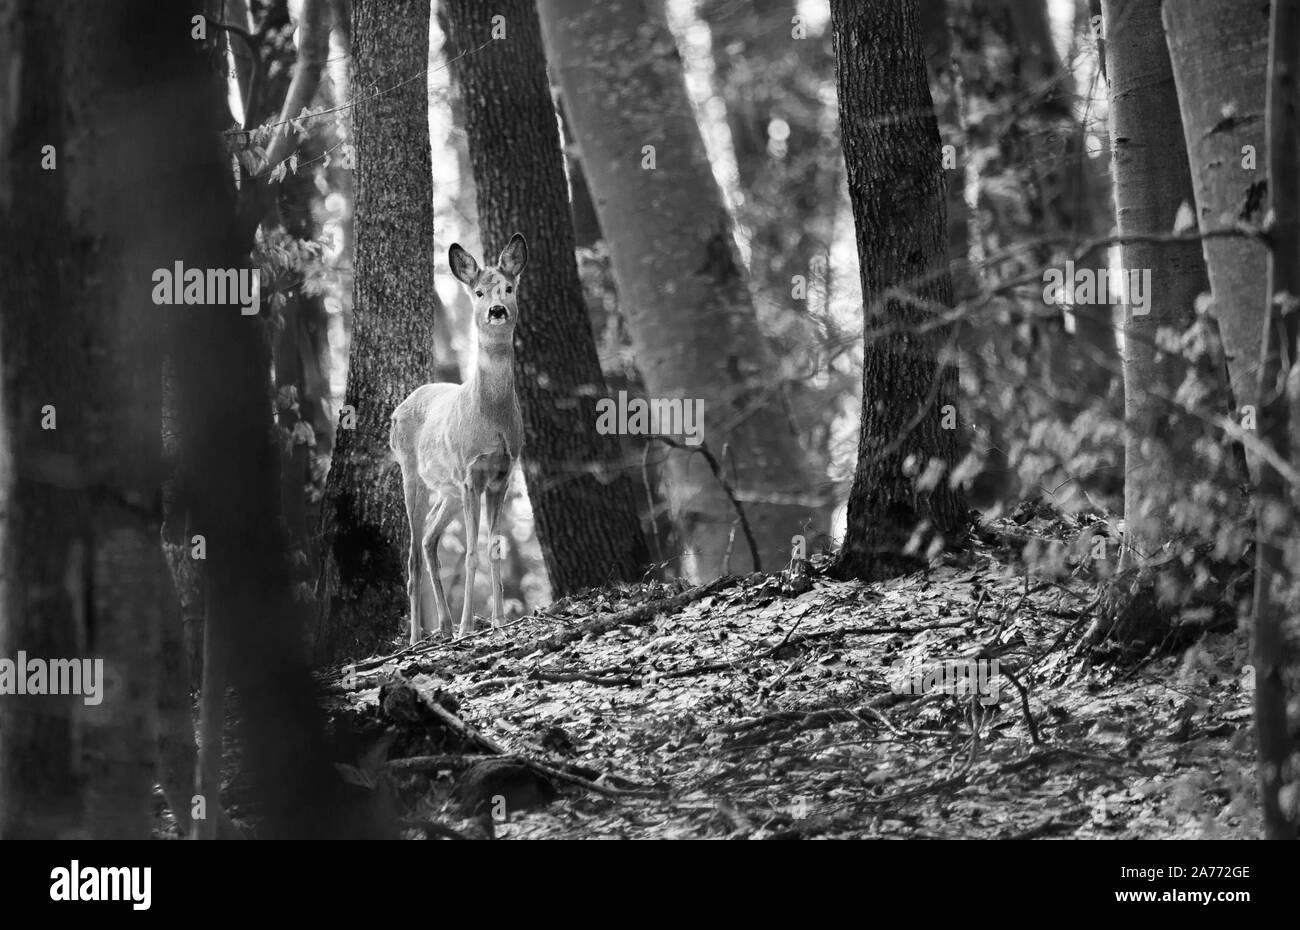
1252,0,1300,839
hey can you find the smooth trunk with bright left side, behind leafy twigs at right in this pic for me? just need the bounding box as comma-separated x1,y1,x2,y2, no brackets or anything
1102,0,1206,558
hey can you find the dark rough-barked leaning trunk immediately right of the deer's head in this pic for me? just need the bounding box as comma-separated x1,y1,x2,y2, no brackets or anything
442,0,649,594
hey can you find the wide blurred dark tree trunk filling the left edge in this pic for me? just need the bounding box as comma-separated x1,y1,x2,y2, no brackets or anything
0,0,179,839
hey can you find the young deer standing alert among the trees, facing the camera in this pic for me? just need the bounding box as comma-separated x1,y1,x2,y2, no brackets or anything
389,233,528,645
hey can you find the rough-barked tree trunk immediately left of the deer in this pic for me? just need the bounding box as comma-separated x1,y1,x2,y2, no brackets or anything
316,0,434,661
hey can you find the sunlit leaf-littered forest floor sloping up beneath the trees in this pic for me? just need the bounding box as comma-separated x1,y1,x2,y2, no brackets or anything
170,504,1258,839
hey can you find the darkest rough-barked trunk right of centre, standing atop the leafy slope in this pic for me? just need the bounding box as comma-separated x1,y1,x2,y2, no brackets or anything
831,0,966,578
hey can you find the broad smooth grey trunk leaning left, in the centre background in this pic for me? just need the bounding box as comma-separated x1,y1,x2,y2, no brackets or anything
538,0,827,576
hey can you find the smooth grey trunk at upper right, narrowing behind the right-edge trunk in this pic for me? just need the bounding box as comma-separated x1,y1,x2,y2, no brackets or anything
1162,0,1269,426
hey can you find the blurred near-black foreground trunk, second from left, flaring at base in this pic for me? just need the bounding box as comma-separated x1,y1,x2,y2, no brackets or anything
162,18,371,839
